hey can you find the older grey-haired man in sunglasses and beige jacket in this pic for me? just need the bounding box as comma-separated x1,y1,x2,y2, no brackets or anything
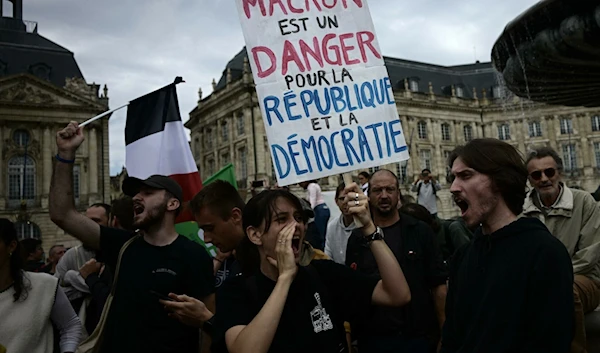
523,147,600,352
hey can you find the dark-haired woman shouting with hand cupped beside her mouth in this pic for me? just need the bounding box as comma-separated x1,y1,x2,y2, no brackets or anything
213,184,410,353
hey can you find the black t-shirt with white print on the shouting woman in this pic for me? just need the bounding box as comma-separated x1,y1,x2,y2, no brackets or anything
213,260,379,353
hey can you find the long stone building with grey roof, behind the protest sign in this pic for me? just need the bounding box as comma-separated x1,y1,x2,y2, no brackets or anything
186,49,600,217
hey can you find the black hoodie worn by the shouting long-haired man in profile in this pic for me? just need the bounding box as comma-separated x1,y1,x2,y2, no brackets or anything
442,218,574,353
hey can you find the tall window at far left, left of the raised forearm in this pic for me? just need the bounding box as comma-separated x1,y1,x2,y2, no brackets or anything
8,156,35,201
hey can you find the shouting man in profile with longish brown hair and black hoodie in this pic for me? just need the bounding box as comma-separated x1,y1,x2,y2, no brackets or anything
442,139,574,353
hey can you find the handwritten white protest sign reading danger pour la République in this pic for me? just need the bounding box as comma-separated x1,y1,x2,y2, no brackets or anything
236,0,409,186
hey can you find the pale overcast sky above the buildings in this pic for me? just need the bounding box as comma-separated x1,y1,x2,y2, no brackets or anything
12,0,536,174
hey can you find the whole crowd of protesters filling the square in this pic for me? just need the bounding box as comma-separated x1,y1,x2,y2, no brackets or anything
0,122,600,353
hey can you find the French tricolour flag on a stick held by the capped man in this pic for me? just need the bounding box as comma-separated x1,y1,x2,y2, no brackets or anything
125,77,202,223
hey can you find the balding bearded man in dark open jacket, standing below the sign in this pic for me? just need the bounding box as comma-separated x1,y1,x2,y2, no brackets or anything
346,169,447,353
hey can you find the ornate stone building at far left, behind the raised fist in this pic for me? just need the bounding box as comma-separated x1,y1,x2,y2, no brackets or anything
0,7,110,253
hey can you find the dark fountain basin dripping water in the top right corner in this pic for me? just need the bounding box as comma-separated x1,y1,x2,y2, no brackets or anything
492,0,600,107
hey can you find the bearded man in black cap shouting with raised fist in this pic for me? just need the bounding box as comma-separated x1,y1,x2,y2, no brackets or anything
50,122,214,353
